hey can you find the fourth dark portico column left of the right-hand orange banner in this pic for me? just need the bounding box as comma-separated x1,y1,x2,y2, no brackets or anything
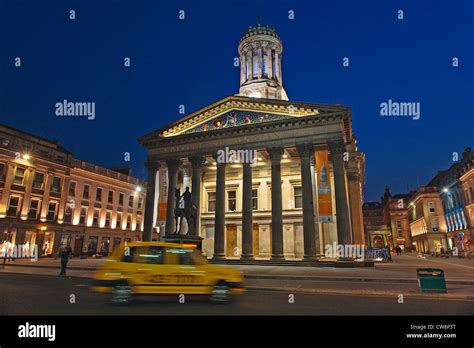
214,157,226,259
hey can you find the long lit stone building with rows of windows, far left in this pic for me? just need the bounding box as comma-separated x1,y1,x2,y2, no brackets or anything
0,125,145,255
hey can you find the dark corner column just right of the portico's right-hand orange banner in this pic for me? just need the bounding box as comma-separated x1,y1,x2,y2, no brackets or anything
329,141,351,244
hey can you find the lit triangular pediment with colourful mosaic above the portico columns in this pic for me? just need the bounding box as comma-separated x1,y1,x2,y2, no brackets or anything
159,97,319,137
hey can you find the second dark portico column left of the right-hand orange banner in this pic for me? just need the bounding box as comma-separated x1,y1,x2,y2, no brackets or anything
267,147,283,259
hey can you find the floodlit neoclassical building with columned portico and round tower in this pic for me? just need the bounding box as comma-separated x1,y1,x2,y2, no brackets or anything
140,25,365,259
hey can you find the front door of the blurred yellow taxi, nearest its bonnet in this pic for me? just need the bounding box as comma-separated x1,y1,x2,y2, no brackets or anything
165,248,209,294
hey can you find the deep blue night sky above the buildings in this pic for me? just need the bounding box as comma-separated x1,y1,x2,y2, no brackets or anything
0,0,474,200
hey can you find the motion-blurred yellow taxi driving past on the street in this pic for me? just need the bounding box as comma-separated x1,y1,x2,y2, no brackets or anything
92,242,245,302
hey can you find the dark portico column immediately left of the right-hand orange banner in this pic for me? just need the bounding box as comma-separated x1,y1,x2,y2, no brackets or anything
296,144,319,259
